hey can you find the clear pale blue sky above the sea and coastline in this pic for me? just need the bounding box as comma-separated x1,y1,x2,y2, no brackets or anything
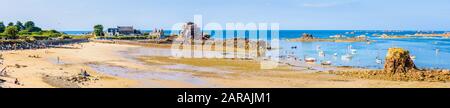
0,0,450,30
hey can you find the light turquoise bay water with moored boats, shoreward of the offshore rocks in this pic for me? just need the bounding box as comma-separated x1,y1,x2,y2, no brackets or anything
281,38,450,69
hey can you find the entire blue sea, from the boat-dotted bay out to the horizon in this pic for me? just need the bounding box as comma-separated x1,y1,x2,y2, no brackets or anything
64,30,450,69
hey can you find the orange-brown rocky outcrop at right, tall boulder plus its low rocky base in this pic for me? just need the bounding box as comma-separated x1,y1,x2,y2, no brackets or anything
330,48,450,82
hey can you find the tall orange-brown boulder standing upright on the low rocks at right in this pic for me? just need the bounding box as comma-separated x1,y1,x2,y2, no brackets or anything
384,48,417,74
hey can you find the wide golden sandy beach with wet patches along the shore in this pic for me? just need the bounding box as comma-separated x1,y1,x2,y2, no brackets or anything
0,42,450,88
